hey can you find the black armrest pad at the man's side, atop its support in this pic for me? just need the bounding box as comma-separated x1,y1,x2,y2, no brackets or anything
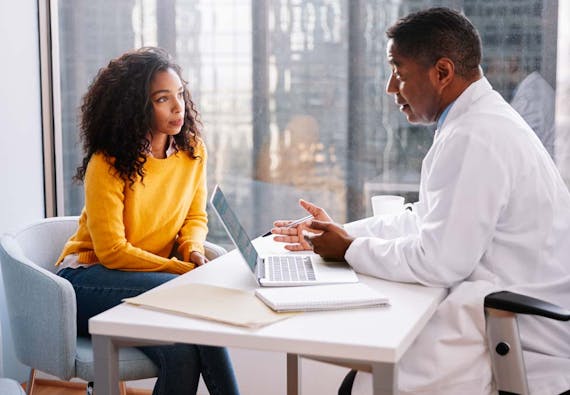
485,291,570,321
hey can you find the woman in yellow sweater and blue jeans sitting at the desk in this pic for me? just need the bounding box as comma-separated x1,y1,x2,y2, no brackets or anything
58,48,239,395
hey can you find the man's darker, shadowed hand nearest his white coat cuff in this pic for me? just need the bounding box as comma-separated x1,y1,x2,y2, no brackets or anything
307,221,354,261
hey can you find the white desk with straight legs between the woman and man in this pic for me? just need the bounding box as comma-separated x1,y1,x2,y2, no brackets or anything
89,240,446,395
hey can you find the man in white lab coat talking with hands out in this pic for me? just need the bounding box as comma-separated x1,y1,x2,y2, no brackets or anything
273,8,570,395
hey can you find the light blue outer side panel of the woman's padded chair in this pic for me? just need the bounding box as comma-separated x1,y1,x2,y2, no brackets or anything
0,235,77,380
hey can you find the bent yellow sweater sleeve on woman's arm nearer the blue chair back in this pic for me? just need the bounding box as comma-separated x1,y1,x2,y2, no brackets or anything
85,154,194,274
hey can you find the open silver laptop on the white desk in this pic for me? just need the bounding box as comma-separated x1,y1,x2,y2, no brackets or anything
210,185,358,287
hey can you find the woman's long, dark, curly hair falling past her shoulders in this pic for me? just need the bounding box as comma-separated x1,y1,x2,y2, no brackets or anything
74,47,201,186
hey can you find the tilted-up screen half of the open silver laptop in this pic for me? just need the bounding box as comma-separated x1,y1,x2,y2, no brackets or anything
210,185,257,273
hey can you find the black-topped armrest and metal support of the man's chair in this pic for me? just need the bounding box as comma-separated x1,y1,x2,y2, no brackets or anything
484,291,570,395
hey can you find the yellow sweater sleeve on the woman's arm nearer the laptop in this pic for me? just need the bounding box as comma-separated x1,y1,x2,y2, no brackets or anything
178,143,208,262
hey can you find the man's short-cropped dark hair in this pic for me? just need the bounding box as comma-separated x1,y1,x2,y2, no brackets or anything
386,7,482,78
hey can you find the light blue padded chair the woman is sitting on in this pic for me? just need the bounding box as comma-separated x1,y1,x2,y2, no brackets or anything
0,216,226,395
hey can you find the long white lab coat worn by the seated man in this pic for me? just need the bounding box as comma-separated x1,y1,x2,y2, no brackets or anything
345,78,570,395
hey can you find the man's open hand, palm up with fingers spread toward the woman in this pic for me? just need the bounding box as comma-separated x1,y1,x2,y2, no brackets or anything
271,199,333,251
